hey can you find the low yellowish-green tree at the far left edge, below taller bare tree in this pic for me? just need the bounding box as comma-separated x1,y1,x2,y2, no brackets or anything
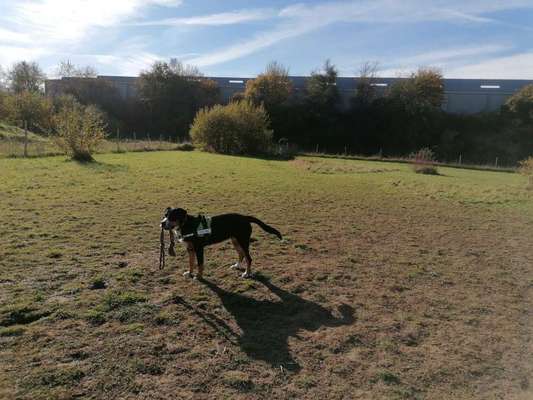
2,91,53,133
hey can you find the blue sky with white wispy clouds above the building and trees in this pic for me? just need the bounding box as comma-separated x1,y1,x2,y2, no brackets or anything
0,0,533,79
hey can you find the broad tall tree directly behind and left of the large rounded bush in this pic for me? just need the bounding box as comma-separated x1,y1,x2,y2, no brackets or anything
138,60,220,137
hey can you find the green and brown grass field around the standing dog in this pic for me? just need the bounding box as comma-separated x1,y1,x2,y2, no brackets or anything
0,152,533,400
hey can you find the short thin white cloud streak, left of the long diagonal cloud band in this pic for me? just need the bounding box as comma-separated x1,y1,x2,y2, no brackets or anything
133,9,276,26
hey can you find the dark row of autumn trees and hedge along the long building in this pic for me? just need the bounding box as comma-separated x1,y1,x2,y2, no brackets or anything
0,61,533,164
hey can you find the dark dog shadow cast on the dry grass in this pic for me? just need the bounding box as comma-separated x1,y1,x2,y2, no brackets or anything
177,276,355,371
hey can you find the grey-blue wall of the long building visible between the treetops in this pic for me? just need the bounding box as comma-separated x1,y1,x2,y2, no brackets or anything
45,76,533,114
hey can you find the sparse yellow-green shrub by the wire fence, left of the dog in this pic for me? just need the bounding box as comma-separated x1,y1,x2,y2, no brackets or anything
54,99,105,161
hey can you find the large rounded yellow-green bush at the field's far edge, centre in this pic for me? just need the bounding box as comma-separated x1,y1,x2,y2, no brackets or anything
190,101,272,154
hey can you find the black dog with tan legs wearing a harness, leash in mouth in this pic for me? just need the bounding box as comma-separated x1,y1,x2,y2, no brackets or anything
161,207,282,279
